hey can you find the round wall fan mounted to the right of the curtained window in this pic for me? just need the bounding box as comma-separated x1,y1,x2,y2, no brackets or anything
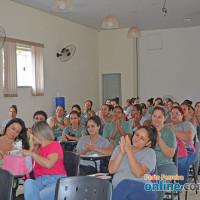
56,44,76,62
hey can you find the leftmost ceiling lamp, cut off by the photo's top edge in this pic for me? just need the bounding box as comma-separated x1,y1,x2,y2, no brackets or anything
52,0,74,12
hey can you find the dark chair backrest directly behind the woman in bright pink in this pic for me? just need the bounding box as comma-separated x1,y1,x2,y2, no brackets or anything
63,151,80,176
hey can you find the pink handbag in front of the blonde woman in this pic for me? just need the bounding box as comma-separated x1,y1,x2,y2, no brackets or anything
2,151,32,179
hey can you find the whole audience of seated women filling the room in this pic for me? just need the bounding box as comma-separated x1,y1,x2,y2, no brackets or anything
0,98,200,200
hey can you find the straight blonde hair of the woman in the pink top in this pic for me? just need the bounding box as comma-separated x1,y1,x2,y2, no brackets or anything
32,121,54,153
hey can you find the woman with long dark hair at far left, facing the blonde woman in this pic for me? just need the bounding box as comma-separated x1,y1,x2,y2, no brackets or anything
0,118,29,168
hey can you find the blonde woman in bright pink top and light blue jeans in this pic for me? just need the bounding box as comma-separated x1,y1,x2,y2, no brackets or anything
20,121,66,200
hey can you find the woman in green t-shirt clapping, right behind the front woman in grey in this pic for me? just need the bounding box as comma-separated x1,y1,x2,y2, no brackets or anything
152,106,178,200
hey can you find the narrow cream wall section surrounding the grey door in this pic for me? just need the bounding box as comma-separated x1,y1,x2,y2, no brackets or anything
99,29,136,108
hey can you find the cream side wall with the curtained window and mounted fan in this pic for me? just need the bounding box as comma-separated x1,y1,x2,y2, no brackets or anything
0,0,99,126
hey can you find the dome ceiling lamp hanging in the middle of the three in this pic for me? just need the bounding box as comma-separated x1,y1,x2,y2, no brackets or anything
102,0,119,29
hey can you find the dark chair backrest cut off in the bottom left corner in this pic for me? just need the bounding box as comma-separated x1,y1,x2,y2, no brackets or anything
0,169,14,200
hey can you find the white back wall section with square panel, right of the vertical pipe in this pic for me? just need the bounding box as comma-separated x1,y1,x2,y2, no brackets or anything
140,27,200,103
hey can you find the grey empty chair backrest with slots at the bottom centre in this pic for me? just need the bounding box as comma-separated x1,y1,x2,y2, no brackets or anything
55,176,112,200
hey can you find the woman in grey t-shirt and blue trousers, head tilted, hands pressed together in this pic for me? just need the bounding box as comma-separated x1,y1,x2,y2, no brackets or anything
108,126,157,200
